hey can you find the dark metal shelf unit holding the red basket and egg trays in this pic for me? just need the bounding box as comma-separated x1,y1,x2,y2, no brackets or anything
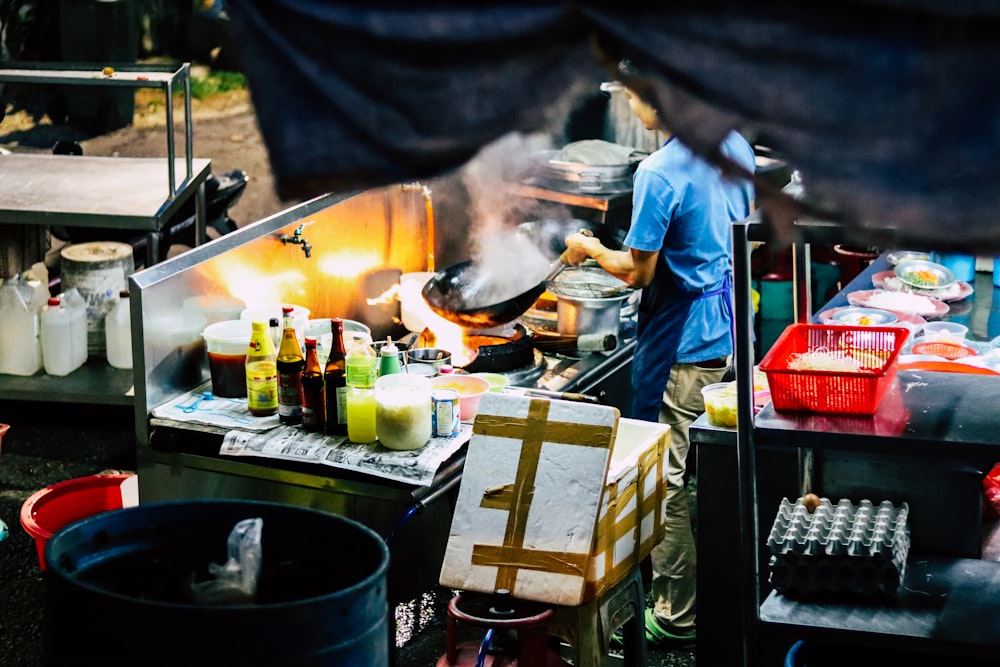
722,218,1000,664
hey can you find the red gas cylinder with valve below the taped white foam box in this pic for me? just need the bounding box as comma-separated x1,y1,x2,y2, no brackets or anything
437,590,567,667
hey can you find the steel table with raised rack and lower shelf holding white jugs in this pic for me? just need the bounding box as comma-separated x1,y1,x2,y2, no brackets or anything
0,62,211,405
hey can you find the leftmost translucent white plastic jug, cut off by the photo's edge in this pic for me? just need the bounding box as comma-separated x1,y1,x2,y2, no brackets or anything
0,278,42,375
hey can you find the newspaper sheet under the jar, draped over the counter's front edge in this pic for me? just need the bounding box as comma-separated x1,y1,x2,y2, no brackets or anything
219,424,472,486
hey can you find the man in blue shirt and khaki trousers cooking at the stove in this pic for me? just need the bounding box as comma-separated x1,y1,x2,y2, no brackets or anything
564,70,754,648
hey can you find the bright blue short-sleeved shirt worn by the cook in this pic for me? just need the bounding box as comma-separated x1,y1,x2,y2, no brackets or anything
625,132,755,363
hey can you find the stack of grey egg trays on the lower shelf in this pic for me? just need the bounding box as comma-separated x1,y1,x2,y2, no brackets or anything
767,498,910,595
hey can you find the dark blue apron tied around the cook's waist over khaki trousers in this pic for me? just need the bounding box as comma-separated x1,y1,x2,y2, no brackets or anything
631,274,736,422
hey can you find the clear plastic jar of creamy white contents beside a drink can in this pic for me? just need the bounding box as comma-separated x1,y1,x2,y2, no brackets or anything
375,373,431,450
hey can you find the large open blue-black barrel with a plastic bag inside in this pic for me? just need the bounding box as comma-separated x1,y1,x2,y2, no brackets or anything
43,500,389,667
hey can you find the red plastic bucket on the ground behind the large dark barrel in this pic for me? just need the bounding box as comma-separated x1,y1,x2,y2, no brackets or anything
19,472,134,570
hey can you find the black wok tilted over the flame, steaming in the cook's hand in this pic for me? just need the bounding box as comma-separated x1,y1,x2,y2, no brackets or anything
421,259,567,329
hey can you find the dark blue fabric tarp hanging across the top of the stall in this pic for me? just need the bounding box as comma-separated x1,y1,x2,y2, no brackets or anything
227,0,1000,247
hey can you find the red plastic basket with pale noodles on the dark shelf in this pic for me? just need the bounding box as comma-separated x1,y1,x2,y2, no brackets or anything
760,324,910,415
